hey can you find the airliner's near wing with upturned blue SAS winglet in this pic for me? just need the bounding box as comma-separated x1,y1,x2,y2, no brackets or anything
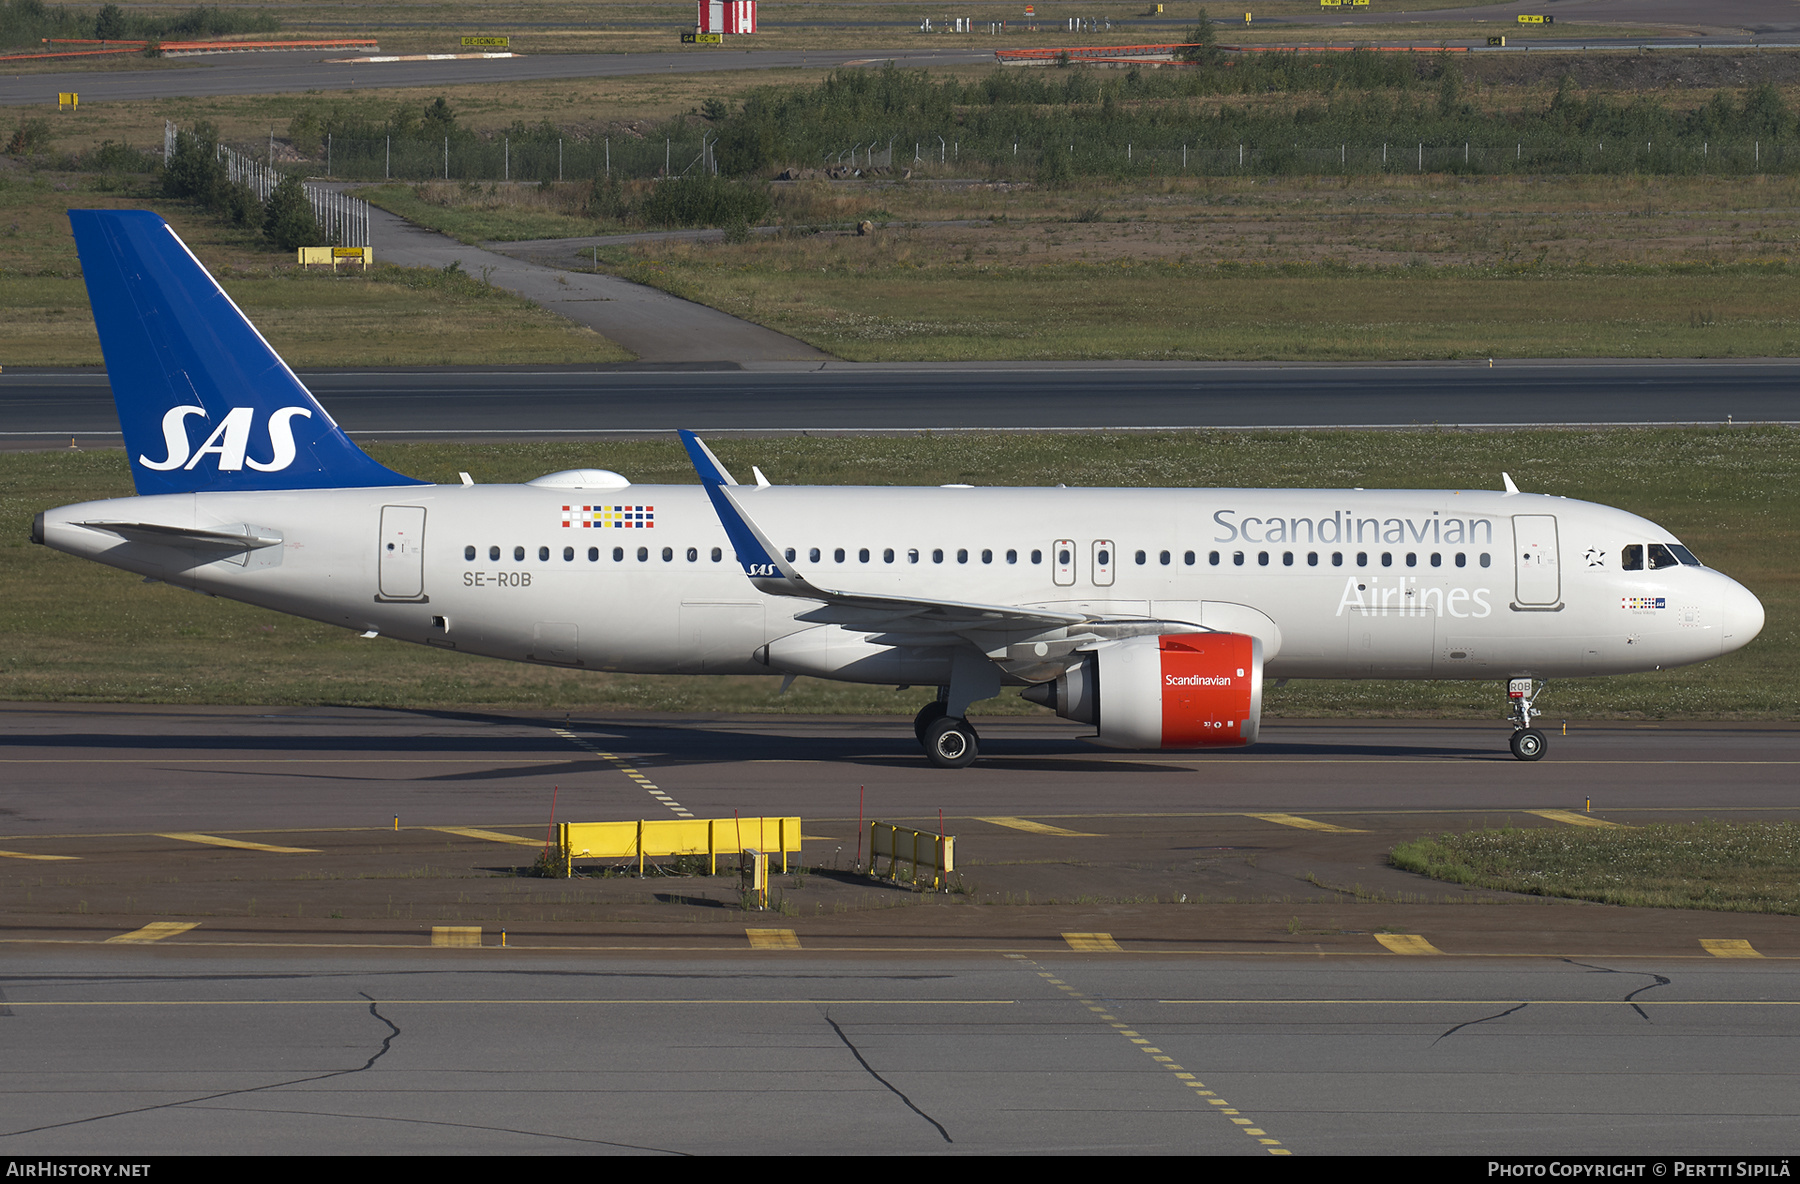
680,432,1094,633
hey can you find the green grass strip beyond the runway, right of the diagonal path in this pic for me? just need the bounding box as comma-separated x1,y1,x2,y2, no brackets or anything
601,259,1800,362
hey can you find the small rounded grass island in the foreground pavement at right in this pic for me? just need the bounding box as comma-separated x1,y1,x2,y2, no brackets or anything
1390,822,1800,914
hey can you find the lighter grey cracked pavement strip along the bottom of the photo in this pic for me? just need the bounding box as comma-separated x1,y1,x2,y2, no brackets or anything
0,946,1800,1157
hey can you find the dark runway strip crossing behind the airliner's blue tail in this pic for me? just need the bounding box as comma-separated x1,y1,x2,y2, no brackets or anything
0,358,1800,448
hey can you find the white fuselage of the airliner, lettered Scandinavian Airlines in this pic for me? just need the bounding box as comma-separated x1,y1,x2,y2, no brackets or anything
43,486,1762,682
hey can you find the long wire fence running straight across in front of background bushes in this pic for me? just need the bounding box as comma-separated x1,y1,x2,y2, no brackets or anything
277,135,1800,182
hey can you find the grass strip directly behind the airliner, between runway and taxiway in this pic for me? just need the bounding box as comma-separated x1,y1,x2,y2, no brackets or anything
0,428,1800,722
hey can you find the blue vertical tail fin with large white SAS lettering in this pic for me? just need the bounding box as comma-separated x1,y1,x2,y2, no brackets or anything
68,211,421,493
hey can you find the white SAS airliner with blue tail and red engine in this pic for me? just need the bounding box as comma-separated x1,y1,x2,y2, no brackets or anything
32,211,1764,768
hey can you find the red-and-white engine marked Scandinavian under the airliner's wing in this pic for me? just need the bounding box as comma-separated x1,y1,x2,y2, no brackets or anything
1024,633,1262,749
